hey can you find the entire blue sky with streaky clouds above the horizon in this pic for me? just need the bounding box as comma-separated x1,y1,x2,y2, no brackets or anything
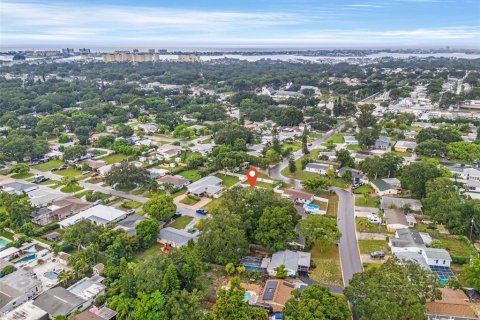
0,0,480,48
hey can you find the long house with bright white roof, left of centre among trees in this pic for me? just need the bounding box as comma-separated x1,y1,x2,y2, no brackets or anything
58,204,127,229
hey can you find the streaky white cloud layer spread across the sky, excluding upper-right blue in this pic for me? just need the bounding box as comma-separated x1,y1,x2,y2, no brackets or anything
0,0,480,46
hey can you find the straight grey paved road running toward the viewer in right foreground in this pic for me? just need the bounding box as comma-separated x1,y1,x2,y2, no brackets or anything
332,188,363,287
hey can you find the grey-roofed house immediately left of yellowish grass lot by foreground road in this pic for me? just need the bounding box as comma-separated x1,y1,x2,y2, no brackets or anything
262,250,311,277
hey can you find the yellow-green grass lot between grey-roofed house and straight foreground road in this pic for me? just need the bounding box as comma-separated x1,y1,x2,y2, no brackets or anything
310,243,343,287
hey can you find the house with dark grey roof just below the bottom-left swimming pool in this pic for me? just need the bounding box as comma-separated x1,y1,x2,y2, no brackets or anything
33,287,89,318
